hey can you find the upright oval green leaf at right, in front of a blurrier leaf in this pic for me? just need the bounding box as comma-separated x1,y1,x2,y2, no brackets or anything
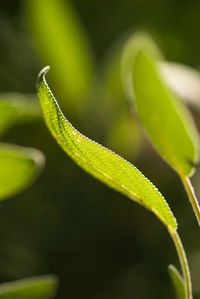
133,51,199,176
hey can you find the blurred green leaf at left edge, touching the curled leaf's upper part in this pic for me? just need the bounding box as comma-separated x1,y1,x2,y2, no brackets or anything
0,93,40,135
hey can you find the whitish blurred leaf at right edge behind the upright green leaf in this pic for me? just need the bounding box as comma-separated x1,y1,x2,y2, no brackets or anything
158,62,200,109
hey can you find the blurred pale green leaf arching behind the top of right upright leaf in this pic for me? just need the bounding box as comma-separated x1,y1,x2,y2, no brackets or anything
121,31,163,101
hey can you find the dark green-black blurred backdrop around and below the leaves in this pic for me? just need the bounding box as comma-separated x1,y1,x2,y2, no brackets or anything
0,0,200,299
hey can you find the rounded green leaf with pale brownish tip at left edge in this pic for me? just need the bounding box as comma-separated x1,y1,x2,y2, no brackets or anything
0,143,44,200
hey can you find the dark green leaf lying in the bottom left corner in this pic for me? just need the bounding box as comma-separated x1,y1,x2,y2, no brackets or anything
0,275,58,299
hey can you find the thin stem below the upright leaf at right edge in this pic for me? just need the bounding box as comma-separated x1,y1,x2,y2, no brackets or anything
181,176,200,226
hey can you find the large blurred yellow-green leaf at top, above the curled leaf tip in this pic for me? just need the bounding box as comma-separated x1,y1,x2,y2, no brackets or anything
24,0,94,108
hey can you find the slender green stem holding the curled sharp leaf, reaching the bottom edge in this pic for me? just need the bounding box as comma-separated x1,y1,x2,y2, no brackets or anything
170,231,192,299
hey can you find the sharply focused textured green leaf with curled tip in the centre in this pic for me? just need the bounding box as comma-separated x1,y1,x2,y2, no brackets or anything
37,67,176,231
